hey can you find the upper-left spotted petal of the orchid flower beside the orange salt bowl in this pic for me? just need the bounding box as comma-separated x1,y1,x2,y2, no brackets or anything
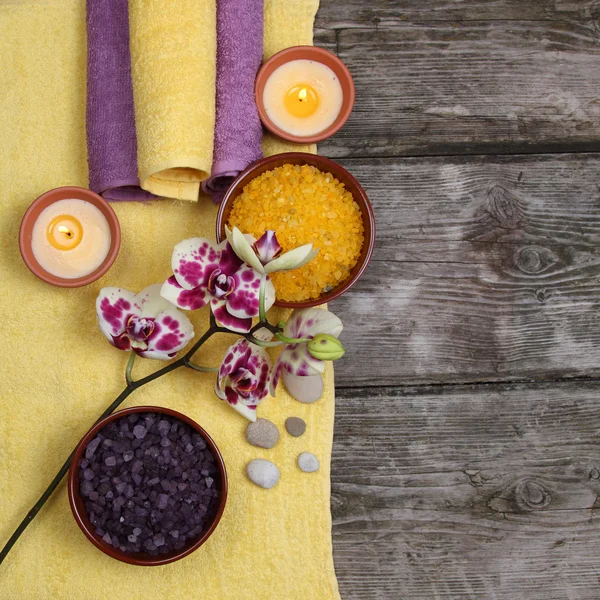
171,238,221,290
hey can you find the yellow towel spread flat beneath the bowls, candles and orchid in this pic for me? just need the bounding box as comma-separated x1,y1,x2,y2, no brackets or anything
0,0,339,600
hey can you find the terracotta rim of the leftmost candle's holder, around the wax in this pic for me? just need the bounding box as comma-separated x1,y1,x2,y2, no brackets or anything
19,186,121,288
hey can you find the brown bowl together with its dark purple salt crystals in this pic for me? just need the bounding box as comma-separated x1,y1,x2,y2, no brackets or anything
68,406,227,566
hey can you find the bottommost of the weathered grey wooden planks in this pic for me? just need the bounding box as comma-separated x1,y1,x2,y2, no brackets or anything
332,383,600,600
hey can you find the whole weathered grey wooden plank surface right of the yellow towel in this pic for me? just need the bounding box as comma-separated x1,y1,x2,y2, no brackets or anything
315,0,600,600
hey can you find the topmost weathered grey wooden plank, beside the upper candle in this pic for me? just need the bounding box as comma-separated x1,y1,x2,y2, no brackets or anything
316,0,600,157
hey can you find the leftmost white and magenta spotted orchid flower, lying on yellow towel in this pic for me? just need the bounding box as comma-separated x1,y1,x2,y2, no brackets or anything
96,284,194,360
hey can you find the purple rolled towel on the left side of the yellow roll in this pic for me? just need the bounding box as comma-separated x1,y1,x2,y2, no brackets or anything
86,0,156,200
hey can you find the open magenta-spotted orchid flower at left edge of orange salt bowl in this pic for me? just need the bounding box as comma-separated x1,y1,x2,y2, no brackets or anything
160,236,275,333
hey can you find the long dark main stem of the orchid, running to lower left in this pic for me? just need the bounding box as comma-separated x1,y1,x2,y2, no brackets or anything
0,324,220,564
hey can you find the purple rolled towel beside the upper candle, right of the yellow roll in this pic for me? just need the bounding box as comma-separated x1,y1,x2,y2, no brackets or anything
202,0,264,203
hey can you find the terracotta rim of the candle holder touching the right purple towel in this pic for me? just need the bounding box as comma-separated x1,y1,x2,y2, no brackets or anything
254,46,355,144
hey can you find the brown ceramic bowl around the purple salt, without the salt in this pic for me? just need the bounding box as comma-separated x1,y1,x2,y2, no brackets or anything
68,406,227,567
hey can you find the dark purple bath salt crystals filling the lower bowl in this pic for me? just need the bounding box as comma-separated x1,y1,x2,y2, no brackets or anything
79,413,220,555
